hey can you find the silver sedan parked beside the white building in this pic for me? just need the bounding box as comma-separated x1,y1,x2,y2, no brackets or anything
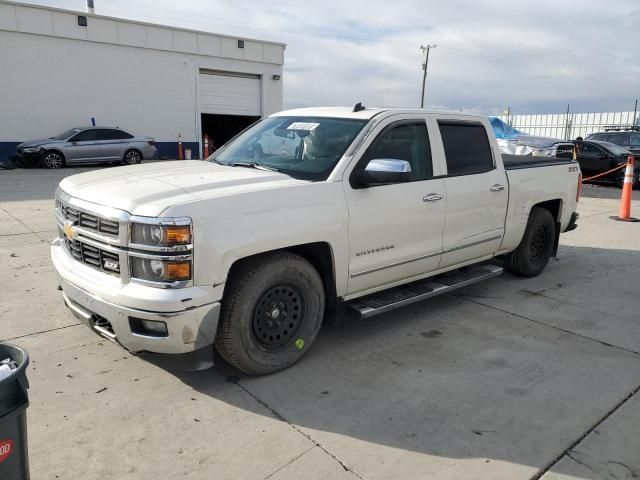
15,127,157,168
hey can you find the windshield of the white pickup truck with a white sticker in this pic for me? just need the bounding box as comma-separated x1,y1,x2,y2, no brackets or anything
209,117,367,180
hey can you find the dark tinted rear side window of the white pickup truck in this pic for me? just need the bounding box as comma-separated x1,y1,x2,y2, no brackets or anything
438,120,495,175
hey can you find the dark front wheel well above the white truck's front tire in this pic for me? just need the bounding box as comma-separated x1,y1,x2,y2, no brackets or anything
230,242,337,311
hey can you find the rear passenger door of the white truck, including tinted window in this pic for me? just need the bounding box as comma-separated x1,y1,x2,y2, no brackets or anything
433,116,509,267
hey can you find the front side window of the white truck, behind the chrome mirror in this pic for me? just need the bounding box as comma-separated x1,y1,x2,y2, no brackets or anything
365,122,433,182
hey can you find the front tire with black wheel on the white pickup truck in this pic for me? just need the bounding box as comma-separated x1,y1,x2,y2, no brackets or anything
215,252,325,375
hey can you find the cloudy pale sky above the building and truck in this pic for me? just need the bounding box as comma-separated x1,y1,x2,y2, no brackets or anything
12,0,640,115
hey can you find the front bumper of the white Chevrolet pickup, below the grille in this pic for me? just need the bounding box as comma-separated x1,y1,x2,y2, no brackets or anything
51,239,220,354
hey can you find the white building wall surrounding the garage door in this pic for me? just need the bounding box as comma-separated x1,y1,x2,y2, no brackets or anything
0,2,284,159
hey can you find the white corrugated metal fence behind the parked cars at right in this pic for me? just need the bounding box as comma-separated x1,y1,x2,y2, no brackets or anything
499,112,640,139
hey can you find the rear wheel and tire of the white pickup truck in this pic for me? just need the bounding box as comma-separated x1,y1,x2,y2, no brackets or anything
506,207,556,277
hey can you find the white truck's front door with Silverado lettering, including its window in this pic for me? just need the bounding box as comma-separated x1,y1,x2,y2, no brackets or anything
344,115,445,295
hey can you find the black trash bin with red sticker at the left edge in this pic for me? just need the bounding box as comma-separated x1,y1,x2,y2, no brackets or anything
0,343,29,480
